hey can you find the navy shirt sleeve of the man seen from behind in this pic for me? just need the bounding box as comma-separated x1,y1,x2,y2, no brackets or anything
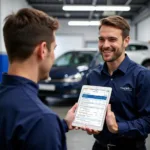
25,114,66,150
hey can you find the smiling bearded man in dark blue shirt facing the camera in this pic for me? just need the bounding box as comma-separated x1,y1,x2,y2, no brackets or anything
86,16,150,150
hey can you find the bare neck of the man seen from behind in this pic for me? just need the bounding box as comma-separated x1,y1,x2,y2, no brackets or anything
8,63,38,83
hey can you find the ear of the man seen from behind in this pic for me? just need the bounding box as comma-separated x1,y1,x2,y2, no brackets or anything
37,42,47,60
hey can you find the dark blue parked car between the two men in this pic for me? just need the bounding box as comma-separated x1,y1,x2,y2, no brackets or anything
39,49,103,99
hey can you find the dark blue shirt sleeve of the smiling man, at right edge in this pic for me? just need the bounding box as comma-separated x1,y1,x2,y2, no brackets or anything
118,70,150,137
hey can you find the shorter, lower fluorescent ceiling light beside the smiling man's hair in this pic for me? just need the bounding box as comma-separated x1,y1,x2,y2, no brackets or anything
68,21,100,26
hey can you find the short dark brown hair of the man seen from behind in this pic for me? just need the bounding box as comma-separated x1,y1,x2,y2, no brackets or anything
3,8,59,63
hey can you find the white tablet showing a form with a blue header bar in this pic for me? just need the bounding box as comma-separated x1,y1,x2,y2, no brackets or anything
72,85,112,131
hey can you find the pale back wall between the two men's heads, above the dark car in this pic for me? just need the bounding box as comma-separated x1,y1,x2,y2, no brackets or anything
55,20,98,58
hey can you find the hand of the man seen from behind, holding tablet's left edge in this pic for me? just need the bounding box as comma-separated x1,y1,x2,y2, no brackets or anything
64,103,78,130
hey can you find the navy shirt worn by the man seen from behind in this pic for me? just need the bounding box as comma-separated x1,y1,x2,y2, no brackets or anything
0,74,68,150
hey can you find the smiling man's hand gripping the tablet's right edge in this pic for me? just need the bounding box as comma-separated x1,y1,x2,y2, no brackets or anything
106,104,118,133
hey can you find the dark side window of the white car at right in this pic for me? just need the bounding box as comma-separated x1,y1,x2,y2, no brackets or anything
126,44,148,51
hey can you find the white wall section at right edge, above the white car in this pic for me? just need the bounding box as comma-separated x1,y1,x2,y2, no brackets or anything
137,17,150,42
